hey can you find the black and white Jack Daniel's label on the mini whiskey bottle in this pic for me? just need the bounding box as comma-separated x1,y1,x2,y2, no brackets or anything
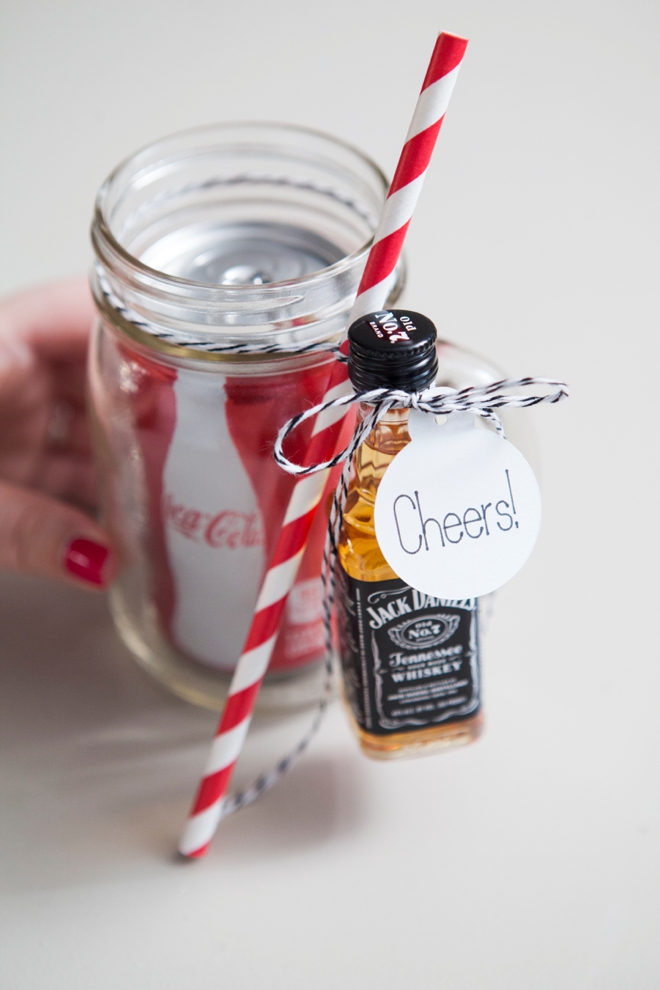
337,566,480,735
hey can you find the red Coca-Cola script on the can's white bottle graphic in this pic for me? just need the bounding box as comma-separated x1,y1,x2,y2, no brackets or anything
163,494,264,550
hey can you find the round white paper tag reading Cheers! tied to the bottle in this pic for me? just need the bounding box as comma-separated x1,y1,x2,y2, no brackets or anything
375,409,541,599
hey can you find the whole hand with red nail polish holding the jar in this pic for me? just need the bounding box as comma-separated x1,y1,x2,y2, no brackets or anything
0,279,116,588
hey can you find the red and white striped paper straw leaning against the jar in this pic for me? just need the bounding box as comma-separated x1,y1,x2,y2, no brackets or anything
179,33,467,858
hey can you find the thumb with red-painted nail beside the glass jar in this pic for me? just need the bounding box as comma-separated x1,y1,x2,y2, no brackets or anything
0,481,117,589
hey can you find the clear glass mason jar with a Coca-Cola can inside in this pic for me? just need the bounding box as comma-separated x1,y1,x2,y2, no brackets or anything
90,124,403,708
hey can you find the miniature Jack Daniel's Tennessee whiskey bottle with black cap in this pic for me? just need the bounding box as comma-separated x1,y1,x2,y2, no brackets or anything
337,310,482,759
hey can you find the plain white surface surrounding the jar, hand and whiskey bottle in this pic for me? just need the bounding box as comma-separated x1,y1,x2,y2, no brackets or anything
0,0,660,990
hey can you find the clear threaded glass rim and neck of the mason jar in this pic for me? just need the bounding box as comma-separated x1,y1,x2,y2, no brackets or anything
91,121,405,352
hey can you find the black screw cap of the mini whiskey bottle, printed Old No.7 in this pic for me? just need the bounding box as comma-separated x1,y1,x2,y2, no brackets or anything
348,309,438,392
